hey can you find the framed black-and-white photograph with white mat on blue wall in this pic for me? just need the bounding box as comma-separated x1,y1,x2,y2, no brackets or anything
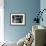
11,14,25,25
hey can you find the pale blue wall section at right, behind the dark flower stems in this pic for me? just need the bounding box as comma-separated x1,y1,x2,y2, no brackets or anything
40,0,46,27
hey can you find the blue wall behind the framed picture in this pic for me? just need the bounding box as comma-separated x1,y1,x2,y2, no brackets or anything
4,0,40,41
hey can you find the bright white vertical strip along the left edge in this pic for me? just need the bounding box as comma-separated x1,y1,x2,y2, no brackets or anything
0,0,4,42
